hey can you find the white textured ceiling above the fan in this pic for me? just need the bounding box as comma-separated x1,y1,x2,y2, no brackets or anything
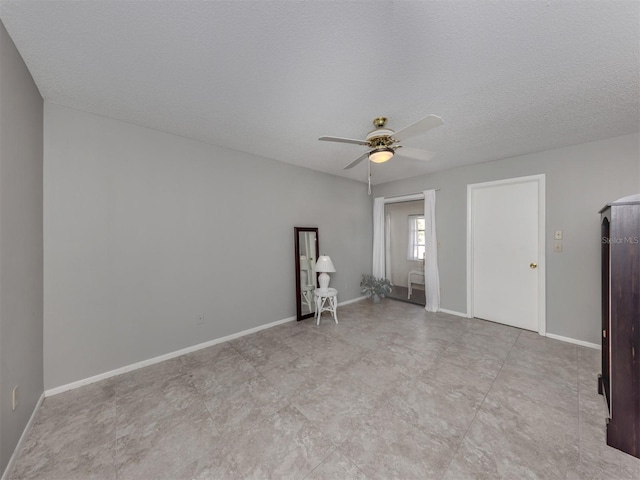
0,0,640,183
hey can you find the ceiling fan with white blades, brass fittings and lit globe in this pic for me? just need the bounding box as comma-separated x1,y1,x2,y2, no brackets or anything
318,115,444,170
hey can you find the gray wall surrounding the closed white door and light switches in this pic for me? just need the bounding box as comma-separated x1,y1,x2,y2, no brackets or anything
373,134,640,344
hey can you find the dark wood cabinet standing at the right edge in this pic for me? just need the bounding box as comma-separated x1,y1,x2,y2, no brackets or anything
598,194,640,458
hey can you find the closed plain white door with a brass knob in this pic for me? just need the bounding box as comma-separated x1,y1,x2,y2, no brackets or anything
469,176,544,333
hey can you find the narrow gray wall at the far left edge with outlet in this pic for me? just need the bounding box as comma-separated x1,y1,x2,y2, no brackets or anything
0,22,43,472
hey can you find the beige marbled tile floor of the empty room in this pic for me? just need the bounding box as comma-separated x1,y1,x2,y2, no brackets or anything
10,299,640,480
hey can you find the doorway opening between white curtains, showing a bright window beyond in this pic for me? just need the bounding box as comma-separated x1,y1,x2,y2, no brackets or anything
384,200,426,306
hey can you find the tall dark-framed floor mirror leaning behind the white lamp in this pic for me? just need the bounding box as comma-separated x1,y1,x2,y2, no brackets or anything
293,227,319,321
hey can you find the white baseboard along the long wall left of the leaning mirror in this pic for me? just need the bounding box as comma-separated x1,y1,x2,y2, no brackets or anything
44,314,298,397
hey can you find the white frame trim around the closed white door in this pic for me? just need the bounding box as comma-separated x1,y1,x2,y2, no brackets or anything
467,174,547,335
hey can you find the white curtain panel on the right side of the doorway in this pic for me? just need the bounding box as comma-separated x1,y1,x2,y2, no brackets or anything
424,190,440,312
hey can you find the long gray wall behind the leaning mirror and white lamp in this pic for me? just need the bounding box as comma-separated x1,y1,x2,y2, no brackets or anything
44,103,372,389
